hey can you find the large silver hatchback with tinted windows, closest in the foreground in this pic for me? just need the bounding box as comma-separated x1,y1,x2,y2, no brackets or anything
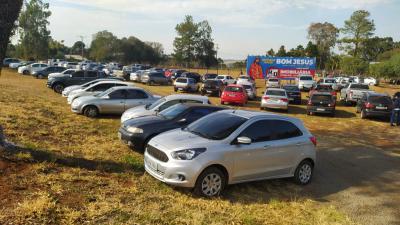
144,110,316,197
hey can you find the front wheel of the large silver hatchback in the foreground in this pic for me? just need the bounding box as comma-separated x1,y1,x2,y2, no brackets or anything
194,167,226,198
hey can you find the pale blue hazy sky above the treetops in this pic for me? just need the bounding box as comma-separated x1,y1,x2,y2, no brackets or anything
47,0,400,60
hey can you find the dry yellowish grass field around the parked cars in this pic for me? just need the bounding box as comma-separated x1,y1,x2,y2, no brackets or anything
0,70,400,224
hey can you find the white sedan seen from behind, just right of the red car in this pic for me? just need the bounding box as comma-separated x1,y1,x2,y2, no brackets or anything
260,88,289,111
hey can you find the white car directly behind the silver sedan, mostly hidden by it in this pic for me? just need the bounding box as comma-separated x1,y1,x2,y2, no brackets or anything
67,80,134,104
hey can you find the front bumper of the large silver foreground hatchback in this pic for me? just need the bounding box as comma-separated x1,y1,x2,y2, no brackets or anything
144,152,202,188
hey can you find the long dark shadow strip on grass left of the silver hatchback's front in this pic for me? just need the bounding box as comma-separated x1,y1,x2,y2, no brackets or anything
2,146,144,174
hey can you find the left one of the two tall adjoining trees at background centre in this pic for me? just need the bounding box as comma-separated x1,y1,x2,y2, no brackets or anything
173,16,198,66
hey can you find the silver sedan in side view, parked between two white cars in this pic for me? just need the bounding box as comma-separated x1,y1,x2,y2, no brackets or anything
71,87,160,117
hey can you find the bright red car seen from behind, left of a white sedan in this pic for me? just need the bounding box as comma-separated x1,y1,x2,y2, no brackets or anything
221,84,247,106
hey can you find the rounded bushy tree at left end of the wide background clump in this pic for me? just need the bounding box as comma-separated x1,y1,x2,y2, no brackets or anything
90,30,120,61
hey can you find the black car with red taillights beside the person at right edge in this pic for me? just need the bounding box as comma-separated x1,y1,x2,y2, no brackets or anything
356,92,393,119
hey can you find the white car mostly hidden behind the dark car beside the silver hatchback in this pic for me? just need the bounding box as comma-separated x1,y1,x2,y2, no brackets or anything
121,94,210,123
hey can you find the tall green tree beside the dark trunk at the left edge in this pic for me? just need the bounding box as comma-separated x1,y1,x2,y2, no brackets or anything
19,0,51,60
